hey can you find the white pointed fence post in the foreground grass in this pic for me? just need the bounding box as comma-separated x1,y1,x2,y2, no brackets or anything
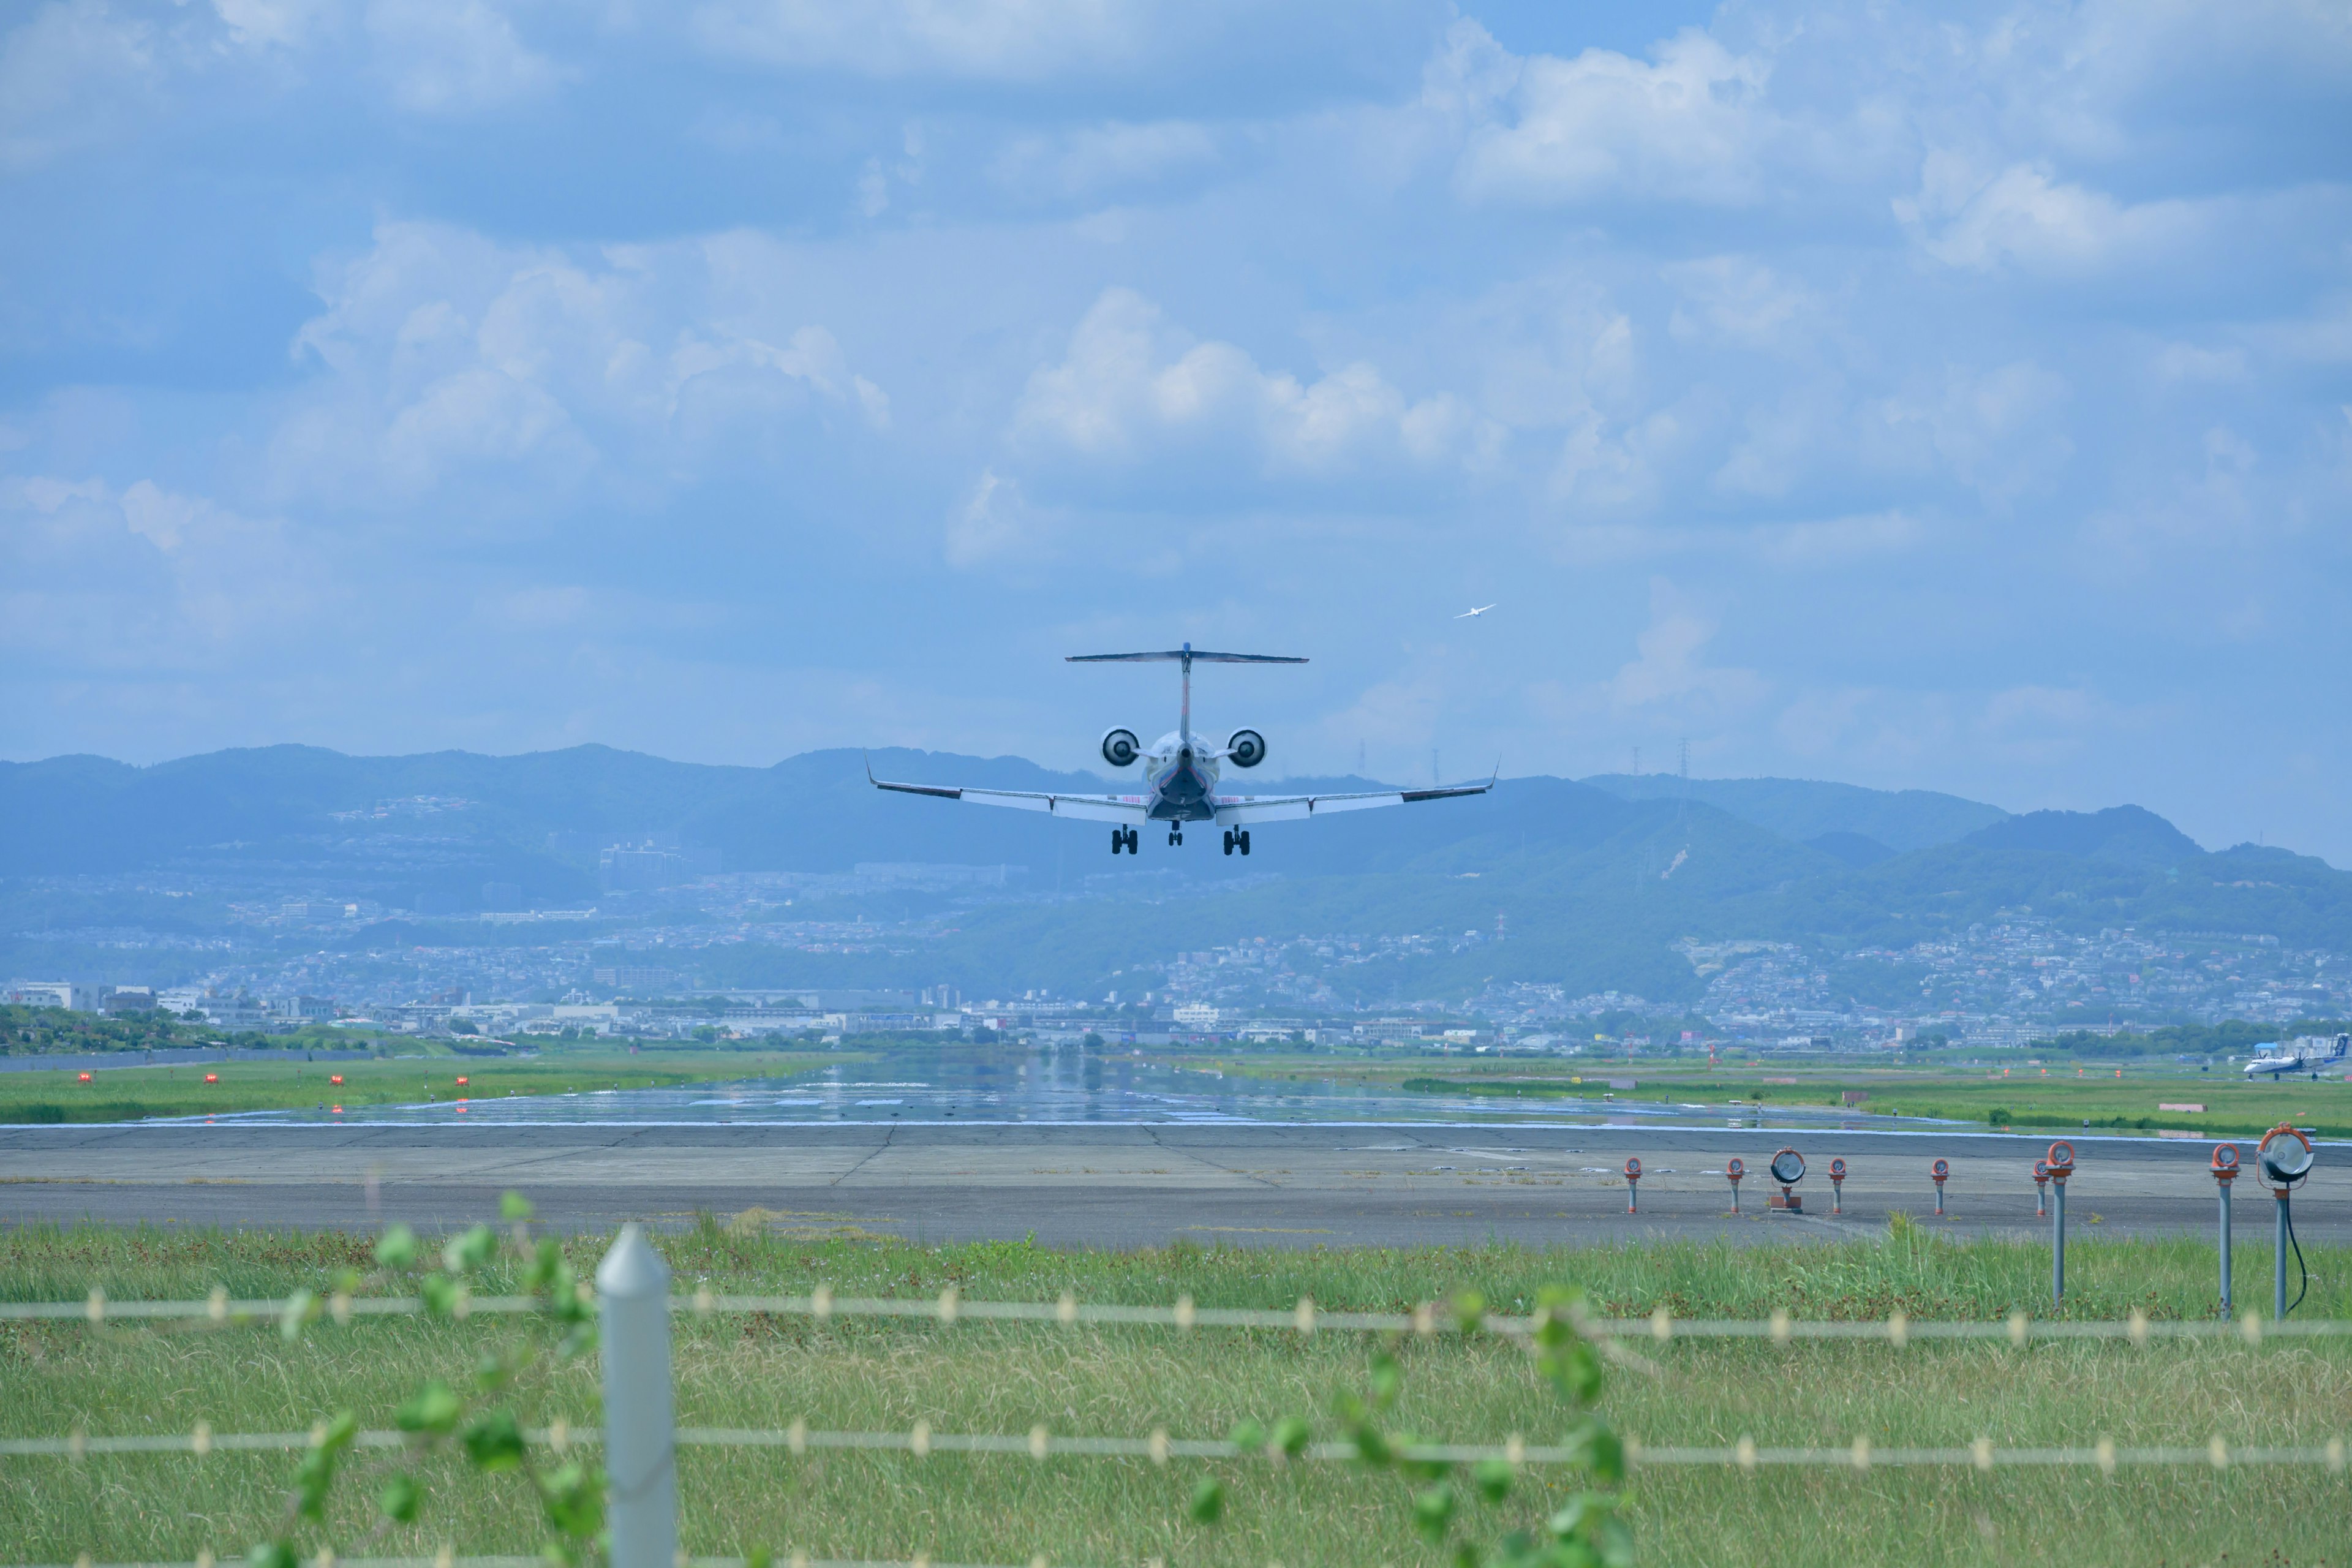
595,1225,677,1568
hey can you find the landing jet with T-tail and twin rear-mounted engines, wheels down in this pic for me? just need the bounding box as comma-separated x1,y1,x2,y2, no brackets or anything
865,642,1493,856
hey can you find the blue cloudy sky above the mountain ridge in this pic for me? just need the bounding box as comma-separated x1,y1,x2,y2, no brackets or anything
13,0,2352,863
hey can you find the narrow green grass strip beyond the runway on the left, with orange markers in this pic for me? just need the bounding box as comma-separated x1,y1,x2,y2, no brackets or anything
0,1046,859,1124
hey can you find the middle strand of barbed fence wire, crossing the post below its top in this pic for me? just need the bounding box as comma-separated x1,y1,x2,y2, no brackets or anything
0,1422,2347,1474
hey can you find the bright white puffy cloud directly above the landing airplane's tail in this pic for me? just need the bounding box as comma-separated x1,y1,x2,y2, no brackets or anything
1014,289,1501,477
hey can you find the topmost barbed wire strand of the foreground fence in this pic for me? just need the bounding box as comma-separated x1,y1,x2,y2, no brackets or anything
0,1284,2352,1347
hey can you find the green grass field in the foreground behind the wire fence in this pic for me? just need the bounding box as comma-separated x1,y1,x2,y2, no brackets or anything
0,1225,2352,1568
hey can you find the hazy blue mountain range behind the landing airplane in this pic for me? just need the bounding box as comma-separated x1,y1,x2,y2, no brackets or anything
0,745,2352,997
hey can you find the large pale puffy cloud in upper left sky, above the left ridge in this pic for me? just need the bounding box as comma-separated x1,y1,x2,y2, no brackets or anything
273,224,891,496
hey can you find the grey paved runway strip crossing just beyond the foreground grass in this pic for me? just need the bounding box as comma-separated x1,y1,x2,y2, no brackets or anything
0,1124,2352,1246
